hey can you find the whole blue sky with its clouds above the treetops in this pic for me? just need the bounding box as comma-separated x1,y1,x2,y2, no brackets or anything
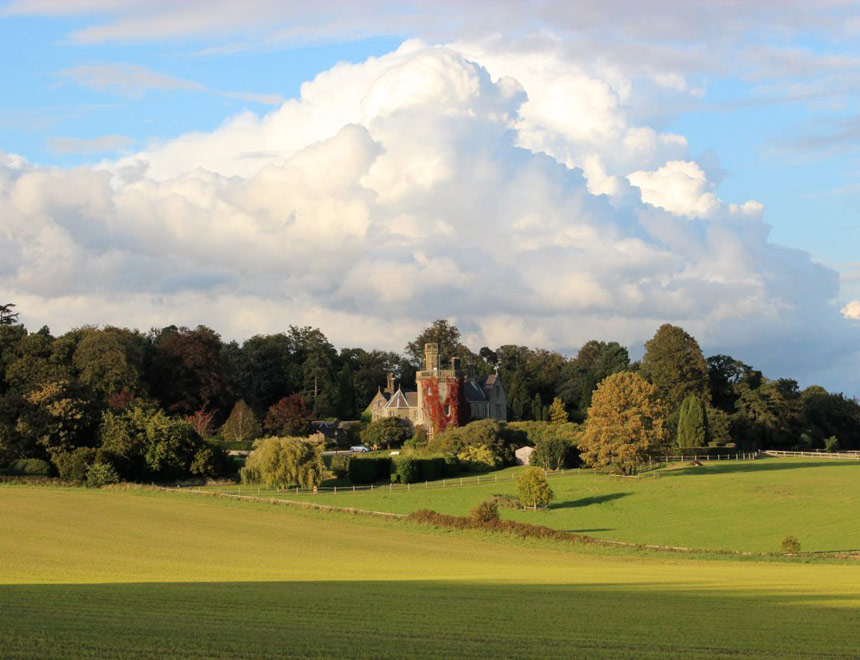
0,0,860,396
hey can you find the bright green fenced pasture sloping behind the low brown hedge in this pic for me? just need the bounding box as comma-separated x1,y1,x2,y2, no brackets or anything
212,458,860,552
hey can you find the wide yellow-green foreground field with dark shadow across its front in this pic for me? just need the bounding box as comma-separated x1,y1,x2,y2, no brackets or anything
0,478,860,658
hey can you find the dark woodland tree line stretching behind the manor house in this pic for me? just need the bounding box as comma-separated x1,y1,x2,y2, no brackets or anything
0,304,860,479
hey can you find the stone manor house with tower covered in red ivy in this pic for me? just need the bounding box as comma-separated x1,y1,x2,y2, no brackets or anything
370,344,507,436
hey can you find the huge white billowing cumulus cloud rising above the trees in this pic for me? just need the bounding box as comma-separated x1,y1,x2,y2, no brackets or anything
0,42,860,391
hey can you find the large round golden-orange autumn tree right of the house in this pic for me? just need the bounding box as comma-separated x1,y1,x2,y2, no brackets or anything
579,372,666,474
